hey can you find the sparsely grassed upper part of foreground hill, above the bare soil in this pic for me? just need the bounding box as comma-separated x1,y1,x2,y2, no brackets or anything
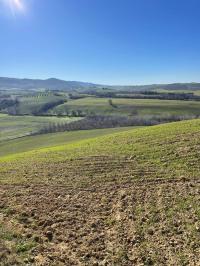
0,120,200,186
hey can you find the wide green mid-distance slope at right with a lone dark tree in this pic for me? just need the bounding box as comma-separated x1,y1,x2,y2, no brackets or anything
52,97,200,115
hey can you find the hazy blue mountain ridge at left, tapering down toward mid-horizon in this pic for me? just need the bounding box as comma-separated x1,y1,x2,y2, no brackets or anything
0,77,98,90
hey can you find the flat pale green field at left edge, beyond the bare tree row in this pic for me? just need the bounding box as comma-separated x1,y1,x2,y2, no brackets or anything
0,114,79,143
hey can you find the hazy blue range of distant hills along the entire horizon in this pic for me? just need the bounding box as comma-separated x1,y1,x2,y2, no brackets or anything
0,77,200,91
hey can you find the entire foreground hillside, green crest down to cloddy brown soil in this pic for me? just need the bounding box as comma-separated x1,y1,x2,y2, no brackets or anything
0,120,200,266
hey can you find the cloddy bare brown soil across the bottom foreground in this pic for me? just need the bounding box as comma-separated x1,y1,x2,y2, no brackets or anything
0,178,200,266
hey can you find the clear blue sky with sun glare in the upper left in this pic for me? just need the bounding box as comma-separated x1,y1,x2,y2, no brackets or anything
0,0,200,84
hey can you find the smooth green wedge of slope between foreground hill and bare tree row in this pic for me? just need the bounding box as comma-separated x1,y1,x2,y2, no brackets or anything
0,125,137,157
